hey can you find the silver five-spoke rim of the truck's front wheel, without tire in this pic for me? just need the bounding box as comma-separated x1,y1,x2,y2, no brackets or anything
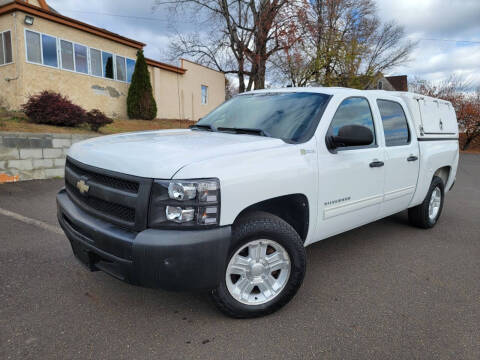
225,239,291,305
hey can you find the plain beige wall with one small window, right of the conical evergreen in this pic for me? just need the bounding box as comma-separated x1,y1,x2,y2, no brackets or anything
150,60,225,120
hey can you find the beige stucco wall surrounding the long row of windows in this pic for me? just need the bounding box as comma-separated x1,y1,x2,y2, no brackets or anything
0,11,137,117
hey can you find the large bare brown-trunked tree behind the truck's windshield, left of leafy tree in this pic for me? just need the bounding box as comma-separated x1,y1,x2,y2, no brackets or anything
155,0,299,92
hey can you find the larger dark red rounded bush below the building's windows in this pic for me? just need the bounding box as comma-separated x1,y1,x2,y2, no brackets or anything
22,90,86,126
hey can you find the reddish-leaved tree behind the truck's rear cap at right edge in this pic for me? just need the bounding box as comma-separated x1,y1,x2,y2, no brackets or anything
409,76,480,150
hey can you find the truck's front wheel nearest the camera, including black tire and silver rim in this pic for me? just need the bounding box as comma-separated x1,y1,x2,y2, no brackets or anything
212,212,306,318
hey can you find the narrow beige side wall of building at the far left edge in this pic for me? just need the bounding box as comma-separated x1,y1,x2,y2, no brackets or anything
0,14,18,109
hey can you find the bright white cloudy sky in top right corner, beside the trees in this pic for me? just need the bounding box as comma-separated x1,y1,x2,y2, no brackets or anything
377,0,480,87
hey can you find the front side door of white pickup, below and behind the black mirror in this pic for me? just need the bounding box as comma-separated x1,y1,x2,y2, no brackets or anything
317,96,385,239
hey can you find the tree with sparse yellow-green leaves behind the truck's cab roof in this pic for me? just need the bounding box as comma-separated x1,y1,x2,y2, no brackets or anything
274,0,415,88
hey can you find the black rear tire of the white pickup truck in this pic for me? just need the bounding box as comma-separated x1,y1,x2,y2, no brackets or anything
408,176,445,229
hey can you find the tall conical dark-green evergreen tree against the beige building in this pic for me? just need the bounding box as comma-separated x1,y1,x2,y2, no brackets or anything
127,50,157,120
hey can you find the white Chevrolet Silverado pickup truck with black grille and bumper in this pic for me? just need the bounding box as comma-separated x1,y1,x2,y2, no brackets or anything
57,88,459,317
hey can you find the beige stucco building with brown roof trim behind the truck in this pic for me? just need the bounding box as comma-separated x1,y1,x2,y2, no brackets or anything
0,0,225,120
